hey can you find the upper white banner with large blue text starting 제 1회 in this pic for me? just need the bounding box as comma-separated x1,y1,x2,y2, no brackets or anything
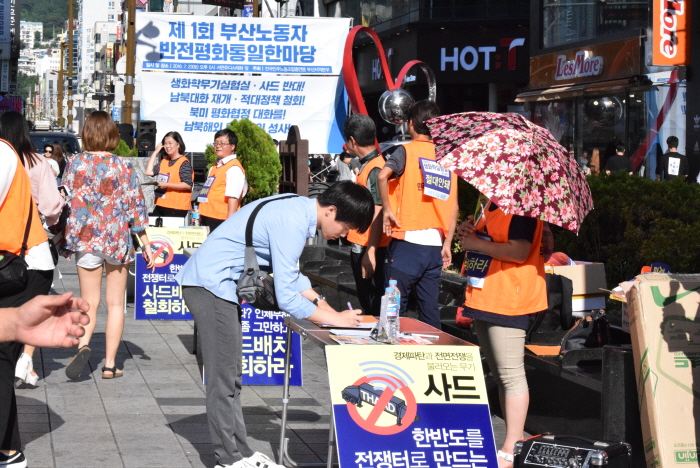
136,13,350,75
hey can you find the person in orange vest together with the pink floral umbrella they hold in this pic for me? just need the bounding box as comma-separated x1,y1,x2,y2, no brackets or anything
426,112,593,468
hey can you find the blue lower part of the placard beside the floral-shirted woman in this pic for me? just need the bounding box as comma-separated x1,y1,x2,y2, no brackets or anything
134,254,192,320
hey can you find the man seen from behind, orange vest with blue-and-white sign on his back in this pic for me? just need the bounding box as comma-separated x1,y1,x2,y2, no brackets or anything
377,101,458,329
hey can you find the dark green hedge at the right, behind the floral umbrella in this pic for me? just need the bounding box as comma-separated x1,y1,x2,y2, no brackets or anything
552,174,700,287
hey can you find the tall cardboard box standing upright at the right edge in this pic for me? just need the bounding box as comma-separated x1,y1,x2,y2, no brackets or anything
623,274,700,468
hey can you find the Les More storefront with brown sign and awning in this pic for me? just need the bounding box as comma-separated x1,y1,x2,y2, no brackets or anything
518,0,686,178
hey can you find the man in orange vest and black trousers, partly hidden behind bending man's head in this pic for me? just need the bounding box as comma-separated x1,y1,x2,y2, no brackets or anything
343,114,391,315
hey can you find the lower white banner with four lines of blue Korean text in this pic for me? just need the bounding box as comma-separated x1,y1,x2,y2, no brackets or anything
141,73,346,153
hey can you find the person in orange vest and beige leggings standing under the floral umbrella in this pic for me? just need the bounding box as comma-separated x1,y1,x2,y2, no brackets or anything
457,202,547,468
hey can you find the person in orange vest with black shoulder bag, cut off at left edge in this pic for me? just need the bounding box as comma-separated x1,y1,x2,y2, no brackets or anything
0,140,55,466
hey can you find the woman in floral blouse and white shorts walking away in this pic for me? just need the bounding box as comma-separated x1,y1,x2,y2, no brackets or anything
64,111,154,380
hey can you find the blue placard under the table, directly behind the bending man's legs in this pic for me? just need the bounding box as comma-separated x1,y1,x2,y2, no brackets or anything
241,303,302,386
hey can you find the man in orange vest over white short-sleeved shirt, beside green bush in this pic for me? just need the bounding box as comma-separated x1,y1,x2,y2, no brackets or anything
197,128,248,232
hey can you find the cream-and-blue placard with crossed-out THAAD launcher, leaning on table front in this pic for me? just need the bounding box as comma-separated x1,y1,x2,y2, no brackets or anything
326,345,498,468
